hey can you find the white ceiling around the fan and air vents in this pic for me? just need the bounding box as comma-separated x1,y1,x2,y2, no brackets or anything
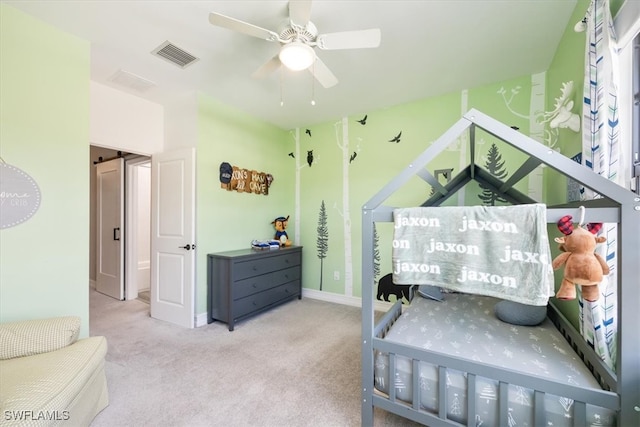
4,0,577,129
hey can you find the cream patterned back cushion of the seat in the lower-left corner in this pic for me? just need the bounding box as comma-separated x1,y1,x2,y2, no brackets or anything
0,316,80,360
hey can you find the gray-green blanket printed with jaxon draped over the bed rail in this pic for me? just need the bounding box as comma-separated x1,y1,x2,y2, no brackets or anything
392,203,554,306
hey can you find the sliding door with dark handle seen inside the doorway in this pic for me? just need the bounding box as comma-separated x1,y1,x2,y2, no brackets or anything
96,158,124,300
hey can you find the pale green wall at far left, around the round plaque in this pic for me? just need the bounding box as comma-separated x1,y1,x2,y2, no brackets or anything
0,4,89,336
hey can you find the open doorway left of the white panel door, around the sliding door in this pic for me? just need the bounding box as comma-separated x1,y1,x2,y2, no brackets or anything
89,146,151,304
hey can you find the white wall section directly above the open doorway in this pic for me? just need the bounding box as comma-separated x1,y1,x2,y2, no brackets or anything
89,81,164,156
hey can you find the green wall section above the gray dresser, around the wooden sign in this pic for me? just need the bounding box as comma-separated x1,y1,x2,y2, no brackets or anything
196,95,295,314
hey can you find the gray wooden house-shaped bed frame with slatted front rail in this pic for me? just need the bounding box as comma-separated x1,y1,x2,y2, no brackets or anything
361,109,640,427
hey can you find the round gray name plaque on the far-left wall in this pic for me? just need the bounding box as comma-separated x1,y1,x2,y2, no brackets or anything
0,162,40,229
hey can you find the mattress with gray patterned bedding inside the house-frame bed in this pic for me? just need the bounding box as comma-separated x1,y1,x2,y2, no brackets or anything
374,293,615,427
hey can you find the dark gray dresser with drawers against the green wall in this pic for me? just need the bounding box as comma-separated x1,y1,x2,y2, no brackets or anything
207,246,302,331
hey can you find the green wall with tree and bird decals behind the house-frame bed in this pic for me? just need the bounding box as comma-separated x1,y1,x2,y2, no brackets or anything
300,72,544,297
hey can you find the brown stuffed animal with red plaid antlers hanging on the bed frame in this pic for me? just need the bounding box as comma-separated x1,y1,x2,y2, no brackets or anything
551,215,609,301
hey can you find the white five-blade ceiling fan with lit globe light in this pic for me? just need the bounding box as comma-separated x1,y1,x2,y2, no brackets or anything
209,0,380,88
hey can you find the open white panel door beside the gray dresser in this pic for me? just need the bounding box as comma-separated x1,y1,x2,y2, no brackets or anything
150,148,196,328
